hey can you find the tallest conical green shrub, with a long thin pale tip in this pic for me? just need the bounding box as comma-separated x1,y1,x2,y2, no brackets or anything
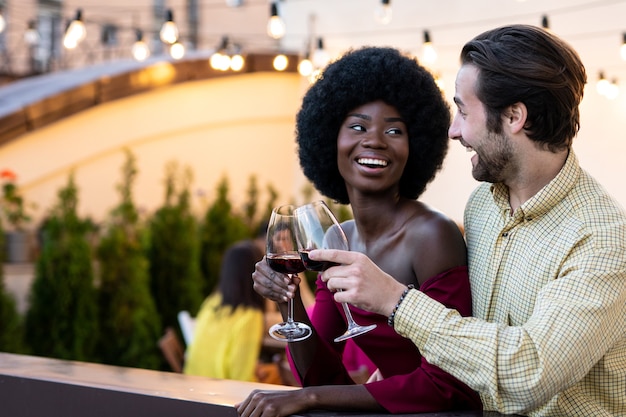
97,151,161,369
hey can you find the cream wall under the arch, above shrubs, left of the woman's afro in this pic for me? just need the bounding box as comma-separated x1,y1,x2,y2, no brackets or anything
0,73,312,226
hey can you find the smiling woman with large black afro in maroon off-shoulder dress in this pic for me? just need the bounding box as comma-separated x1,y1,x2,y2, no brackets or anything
236,47,481,416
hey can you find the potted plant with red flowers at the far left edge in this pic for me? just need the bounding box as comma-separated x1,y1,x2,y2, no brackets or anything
0,169,31,263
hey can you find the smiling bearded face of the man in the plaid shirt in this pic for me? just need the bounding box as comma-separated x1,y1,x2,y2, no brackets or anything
448,65,514,183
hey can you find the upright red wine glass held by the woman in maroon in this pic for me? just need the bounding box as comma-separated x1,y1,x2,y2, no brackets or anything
265,205,311,342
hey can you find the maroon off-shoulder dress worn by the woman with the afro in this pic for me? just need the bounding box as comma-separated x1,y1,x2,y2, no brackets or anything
290,266,482,414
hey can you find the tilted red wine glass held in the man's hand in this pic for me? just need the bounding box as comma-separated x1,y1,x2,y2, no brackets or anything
294,200,376,342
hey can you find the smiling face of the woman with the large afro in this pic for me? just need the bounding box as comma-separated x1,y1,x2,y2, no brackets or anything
337,101,409,197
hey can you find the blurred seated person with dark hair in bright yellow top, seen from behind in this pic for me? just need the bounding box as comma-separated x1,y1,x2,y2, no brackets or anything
183,241,268,383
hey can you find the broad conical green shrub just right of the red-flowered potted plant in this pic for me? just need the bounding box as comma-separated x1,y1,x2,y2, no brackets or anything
26,175,98,361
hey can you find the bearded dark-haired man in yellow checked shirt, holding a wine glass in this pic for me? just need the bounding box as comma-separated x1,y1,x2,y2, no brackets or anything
311,25,626,417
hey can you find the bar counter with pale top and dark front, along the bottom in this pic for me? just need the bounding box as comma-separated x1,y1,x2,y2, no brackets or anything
0,353,516,417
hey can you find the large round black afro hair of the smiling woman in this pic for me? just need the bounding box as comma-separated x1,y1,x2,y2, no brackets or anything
296,47,450,204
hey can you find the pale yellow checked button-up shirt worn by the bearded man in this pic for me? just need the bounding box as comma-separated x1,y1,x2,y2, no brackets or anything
395,151,626,417
